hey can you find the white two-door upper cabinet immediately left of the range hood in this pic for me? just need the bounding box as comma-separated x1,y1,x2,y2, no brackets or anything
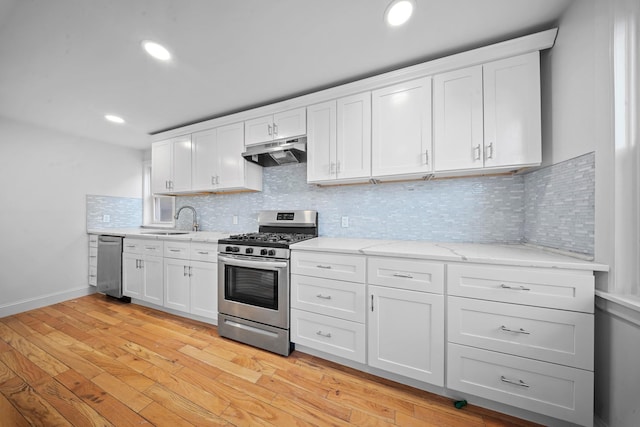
192,123,262,191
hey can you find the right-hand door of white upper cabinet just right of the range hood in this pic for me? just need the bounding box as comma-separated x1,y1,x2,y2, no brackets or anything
335,92,371,179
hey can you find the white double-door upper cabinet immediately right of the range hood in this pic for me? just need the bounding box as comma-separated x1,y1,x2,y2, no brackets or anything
307,92,371,183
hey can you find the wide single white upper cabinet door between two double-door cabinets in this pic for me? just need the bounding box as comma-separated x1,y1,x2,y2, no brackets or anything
371,77,432,178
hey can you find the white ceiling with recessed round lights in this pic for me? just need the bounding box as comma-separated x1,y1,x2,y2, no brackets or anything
0,0,572,148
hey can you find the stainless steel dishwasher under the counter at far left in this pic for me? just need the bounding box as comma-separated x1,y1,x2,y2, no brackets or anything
97,235,131,302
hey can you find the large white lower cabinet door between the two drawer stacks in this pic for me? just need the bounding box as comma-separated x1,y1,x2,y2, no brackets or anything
368,285,444,386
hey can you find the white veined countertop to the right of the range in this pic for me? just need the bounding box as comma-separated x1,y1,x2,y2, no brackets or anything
291,237,609,271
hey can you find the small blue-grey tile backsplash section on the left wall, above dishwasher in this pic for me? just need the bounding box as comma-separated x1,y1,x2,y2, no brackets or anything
87,194,142,229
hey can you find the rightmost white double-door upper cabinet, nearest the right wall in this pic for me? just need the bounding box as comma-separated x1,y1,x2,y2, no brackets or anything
433,52,542,172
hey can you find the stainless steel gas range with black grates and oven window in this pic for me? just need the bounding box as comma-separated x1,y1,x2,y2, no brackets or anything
218,211,318,356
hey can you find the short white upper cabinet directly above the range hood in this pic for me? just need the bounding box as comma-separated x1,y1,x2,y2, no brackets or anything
244,108,307,145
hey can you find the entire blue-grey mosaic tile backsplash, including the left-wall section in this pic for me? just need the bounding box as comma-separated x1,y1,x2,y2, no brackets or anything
87,153,595,255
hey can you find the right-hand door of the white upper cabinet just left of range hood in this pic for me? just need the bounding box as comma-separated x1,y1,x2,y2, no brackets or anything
217,123,246,188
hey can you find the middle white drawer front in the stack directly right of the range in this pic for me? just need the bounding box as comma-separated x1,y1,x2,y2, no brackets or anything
291,274,366,323
